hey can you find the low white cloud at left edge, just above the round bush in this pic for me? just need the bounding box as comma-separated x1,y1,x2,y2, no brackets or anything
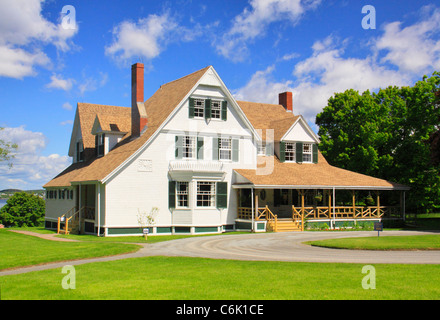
0,126,70,189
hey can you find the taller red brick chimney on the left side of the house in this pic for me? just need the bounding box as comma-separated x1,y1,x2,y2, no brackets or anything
131,63,147,137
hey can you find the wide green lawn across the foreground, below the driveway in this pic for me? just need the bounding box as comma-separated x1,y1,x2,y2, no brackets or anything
0,257,440,300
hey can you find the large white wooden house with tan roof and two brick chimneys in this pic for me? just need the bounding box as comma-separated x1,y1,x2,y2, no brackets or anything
44,63,408,236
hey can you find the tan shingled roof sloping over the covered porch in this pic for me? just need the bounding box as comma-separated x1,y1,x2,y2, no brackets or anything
233,153,410,190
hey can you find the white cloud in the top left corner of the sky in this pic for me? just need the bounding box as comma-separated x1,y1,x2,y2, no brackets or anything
0,0,78,79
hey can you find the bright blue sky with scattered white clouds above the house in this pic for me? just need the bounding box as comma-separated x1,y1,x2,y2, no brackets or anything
0,0,440,189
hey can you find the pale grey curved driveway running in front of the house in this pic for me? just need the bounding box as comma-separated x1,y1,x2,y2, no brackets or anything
0,231,440,276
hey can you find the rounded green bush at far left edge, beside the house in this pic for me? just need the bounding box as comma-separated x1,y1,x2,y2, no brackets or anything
0,192,46,227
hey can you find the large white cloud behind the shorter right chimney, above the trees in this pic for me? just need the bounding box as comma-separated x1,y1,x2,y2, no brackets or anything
235,36,410,123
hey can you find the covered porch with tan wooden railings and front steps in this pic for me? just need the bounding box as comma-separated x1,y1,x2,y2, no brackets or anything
233,184,405,232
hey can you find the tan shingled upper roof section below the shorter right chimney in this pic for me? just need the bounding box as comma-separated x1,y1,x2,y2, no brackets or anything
237,101,299,141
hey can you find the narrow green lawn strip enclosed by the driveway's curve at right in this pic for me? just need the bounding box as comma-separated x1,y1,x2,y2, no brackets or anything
306,235,440,250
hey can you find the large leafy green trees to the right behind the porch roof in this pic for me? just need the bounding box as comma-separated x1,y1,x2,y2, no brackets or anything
316,72,440,212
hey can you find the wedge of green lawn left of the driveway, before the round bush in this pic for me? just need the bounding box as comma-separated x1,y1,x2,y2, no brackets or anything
0,229,139,270
